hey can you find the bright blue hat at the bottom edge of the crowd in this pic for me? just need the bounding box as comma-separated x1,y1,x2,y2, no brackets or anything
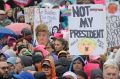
13,71,35,79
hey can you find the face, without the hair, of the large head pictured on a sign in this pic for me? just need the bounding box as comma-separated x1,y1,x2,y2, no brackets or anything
37,32,48,45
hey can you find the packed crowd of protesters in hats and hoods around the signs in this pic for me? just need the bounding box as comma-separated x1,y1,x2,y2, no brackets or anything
0,0,120,79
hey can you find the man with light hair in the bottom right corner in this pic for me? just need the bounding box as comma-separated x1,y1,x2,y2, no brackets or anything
103,59,119,79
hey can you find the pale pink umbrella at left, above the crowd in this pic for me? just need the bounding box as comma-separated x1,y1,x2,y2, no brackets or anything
6,23,31,35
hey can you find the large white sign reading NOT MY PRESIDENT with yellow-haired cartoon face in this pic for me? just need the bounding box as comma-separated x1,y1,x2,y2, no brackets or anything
69,4,106,55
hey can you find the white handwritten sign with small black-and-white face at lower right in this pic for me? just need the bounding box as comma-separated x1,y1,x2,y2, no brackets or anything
34,8,60,34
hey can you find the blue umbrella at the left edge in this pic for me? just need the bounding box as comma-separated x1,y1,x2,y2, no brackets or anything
0,27,17,38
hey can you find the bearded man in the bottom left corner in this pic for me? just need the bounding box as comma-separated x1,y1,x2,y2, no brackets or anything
0,61,9,79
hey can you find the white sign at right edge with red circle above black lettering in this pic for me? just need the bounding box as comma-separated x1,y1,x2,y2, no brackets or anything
106,1,120,47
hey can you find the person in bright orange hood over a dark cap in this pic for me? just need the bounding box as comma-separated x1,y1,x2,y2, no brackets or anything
39,58,57,79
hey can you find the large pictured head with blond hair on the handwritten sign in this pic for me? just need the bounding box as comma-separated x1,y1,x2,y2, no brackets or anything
35,24,49,45
